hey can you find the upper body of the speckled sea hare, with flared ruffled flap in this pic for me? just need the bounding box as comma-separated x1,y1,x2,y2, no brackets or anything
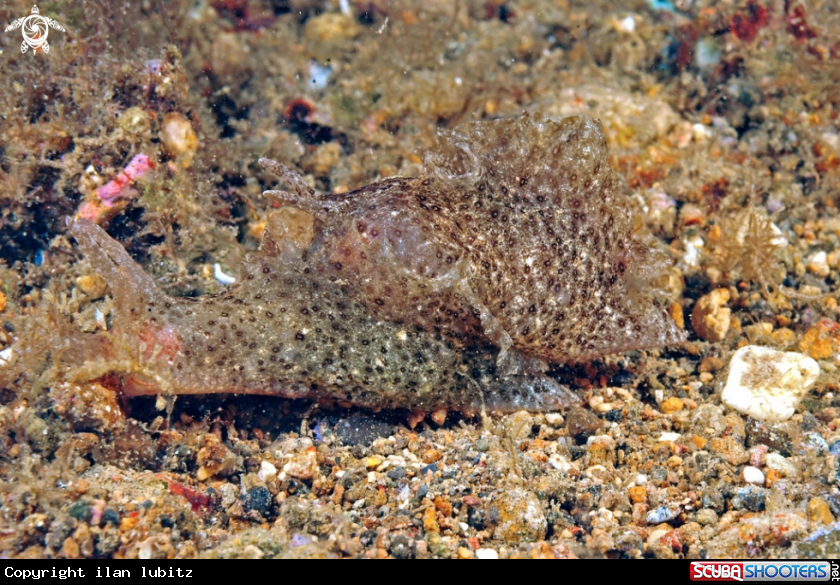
263,115,683,363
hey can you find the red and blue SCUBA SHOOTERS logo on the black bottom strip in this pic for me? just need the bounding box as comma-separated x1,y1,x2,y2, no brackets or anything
690,561,840,581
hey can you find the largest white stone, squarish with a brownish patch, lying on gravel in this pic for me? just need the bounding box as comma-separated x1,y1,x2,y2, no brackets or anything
721,345,820,422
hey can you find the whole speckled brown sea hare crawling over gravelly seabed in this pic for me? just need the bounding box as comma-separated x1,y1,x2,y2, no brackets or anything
72,116,683,413
